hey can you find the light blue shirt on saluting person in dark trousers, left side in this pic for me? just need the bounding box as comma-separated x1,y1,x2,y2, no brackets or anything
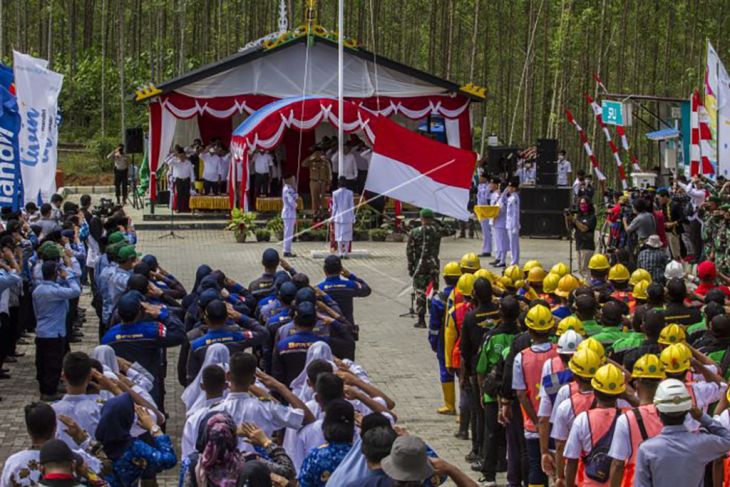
33,277,81,338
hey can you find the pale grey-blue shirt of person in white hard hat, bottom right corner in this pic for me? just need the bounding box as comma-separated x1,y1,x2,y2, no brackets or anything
634,414,730,487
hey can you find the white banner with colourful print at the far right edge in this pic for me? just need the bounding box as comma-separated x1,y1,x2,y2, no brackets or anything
704,41,730,177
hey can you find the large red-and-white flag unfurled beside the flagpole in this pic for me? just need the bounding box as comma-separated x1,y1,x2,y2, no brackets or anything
365,117,476,220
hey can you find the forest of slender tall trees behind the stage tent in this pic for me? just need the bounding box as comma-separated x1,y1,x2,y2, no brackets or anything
0,0,730,187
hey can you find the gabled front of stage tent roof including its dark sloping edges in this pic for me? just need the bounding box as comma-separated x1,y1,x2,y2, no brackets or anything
142,36,483,101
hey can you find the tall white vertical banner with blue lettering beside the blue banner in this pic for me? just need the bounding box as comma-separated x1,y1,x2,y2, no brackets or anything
13,51,63,202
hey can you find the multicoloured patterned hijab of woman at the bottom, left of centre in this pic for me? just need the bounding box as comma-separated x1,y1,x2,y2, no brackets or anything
195,412,245,487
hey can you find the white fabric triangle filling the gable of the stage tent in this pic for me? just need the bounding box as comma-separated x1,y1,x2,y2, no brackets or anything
176,43,447,98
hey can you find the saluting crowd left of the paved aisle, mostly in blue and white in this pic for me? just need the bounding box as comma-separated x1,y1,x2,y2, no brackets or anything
0,196,484,487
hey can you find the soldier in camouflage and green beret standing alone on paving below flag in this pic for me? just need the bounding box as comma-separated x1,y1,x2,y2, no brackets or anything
406,208,441,328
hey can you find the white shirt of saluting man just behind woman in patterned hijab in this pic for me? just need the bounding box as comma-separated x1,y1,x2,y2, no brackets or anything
211,392,304,452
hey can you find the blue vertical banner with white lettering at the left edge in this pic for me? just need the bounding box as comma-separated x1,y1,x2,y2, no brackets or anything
0,85,23,211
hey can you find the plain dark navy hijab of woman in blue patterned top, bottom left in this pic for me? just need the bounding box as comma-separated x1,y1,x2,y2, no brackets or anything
96,392,134,460
